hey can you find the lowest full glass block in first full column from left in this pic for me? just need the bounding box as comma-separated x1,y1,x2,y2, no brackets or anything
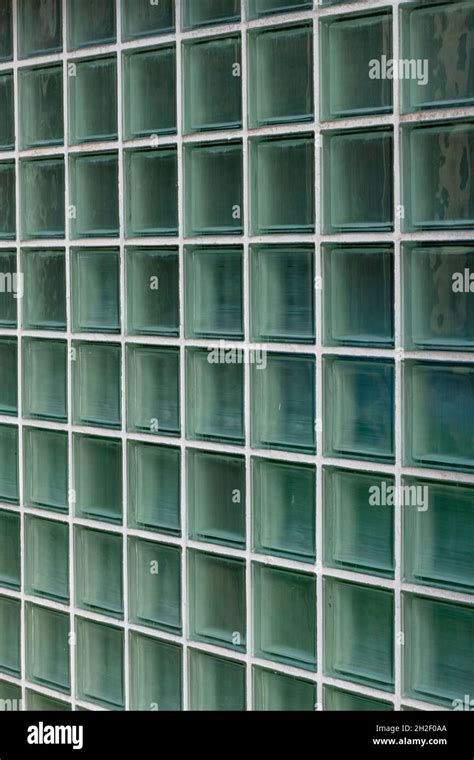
25,603,71,694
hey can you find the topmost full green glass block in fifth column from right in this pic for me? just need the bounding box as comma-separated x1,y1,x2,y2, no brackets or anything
123,45,176,140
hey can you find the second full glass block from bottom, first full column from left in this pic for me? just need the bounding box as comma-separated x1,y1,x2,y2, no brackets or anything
25,515,69,604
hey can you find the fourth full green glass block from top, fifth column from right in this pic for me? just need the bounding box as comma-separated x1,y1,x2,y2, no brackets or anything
127,344,181,436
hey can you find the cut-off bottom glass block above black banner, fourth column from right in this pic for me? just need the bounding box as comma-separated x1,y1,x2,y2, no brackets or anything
188,648,246,712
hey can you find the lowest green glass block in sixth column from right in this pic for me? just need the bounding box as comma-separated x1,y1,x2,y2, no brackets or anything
76,618,125,710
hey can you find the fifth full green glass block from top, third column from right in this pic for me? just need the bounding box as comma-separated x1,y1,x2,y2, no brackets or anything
252,457,316,562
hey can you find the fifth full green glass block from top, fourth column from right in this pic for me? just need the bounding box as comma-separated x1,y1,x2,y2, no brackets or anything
186,449,245,549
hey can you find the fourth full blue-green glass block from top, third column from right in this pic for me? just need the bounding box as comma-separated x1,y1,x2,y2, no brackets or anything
250,353,316,454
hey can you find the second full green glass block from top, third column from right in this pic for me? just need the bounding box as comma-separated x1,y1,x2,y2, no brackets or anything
250,135,315,235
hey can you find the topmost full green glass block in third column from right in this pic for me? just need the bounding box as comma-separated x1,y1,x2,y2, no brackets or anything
248,24,314,129
